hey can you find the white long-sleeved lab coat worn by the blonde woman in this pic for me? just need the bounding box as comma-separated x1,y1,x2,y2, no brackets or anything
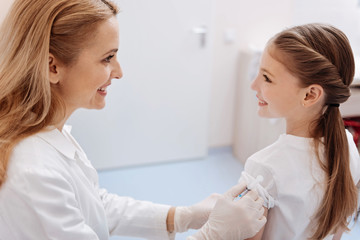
0,126,174,240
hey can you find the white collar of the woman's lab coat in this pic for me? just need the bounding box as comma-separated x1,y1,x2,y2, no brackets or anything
37,125,76,160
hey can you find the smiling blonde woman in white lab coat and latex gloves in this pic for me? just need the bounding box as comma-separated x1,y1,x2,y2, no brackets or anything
0,0,266,240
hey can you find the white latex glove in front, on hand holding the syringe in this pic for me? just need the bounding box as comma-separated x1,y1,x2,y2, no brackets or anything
187,184,266,240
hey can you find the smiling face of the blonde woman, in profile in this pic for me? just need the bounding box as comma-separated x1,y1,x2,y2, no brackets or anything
57,17,122,115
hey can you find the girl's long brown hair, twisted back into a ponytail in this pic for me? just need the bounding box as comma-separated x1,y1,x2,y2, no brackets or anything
269,24,357,239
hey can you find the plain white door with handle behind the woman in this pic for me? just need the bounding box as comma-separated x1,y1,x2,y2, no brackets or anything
68,0,212,169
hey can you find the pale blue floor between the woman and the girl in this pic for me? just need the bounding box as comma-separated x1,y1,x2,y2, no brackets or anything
99,148,360,240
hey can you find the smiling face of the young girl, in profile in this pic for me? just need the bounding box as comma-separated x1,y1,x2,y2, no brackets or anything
251,47,305,120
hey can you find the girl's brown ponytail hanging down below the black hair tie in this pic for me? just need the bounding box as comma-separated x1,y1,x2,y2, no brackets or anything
312,106,357,239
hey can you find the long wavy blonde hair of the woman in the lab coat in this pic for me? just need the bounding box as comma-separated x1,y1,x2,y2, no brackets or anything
0,0,118,187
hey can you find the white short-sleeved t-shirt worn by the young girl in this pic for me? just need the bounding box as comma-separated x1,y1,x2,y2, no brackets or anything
239,131,360,240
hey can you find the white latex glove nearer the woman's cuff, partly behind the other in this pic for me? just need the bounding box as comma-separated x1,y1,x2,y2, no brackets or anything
174,193,222,232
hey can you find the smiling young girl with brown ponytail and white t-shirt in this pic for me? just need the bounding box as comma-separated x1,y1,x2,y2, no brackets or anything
240,24,360,240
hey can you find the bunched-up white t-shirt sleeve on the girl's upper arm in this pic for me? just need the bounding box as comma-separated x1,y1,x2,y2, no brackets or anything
239,159,277,209
